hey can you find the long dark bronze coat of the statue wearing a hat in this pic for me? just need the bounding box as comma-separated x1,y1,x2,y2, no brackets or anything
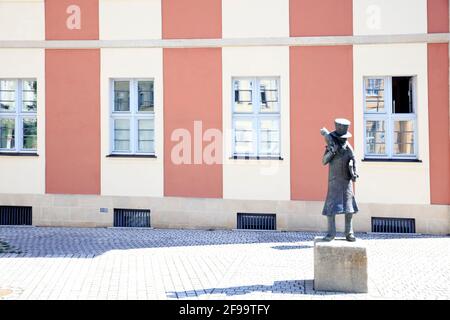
322,139,358,216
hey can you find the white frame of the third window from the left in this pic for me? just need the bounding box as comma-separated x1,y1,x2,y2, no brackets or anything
231,76,282,158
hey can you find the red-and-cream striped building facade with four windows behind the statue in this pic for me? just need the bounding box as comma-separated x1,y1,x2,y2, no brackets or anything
0,0,450,234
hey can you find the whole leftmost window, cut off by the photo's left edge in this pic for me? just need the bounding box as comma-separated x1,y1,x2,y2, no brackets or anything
0,79,37,153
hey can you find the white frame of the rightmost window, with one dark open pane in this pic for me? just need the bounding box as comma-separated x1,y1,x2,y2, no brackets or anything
363,75,418,159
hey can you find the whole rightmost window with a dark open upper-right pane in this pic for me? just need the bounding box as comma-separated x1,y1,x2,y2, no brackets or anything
364,77,417,159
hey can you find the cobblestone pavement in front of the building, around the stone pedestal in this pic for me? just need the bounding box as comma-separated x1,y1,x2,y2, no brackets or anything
0,227,450,300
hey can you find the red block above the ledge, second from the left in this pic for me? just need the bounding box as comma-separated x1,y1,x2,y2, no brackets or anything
162,0,222,39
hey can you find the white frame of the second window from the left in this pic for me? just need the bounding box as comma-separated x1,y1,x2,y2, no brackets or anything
109,78,156,156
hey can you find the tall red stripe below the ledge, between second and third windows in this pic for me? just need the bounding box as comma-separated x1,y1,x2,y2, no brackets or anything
164,49,223,198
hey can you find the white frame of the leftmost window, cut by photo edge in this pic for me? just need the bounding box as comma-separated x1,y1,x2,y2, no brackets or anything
0,78,38,154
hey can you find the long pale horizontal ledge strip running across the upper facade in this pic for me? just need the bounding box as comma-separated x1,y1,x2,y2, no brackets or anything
0,33,450,49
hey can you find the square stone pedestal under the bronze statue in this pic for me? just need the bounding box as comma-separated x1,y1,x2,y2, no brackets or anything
314,237,368,293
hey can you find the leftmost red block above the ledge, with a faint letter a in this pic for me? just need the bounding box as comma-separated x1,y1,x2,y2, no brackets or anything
45,0,98,40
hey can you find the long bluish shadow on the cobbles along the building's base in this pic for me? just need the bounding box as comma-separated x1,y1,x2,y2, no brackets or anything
0,227,450,258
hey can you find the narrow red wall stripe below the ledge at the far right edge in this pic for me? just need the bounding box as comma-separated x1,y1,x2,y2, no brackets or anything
428,43,450,204
